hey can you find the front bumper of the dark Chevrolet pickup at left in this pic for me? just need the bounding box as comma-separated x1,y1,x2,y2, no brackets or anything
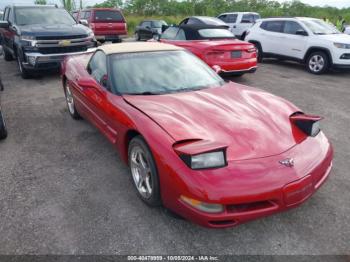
23,48,96,70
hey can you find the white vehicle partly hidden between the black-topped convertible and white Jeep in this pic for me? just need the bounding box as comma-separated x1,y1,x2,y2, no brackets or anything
218,12,260,40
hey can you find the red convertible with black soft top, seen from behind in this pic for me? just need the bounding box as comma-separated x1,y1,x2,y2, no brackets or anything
159,25,257,76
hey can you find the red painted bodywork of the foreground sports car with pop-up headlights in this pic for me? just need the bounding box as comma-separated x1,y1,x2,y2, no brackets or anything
62,52,333,228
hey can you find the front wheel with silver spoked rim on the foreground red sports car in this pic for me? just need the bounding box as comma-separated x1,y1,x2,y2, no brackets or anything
128,136,161,206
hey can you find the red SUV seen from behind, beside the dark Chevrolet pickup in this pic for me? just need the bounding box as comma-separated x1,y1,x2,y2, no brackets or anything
77,8,128,43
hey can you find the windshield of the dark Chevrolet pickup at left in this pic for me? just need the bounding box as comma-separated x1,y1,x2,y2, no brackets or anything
15,7,76,25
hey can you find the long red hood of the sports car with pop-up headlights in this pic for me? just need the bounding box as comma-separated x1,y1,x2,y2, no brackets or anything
124,83,300,161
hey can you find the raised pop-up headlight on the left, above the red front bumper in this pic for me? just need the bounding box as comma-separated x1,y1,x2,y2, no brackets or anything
181,151,226,169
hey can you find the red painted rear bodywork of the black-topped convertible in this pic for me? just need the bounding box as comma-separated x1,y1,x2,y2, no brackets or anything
160,39,257,72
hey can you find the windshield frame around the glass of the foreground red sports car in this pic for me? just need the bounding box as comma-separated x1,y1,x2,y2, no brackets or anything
107,50,225,96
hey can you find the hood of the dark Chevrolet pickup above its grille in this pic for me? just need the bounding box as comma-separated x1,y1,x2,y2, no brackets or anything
20,24,90,37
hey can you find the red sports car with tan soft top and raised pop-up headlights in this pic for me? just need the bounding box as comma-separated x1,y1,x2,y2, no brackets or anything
62,42,333,227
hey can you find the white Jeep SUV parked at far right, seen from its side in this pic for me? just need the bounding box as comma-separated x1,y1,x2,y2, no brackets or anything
245,17,350,74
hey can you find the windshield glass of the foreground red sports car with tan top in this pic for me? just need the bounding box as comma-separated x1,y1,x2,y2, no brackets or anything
110,51,224,95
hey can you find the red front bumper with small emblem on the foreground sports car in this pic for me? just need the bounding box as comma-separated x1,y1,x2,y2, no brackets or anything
162,133,333,228
